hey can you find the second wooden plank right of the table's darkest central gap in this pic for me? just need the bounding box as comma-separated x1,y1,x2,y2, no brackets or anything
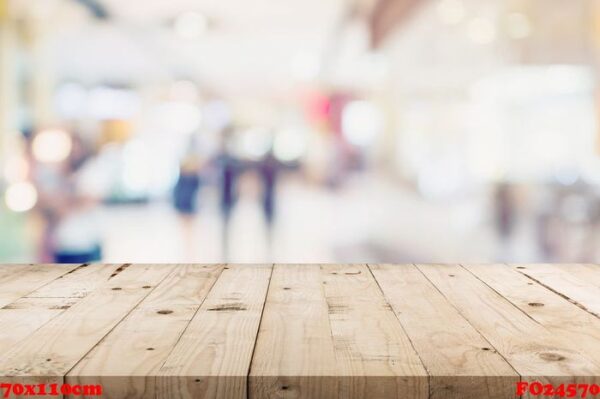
321,265,429,399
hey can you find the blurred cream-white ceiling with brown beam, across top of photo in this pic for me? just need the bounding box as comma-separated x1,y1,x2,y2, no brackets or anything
9,0,600,99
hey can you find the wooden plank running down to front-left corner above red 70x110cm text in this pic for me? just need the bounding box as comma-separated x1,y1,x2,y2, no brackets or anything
0,265,173,398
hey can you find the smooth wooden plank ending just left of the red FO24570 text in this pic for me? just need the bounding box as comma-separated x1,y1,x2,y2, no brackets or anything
369,265,519,399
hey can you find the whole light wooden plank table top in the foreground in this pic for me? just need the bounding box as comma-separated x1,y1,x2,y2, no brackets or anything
0,264,600,399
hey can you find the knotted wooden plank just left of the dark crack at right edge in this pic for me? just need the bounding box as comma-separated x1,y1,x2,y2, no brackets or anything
465,265,600,372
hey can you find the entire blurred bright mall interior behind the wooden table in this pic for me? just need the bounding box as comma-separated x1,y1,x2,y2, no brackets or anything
0,0,600,262
